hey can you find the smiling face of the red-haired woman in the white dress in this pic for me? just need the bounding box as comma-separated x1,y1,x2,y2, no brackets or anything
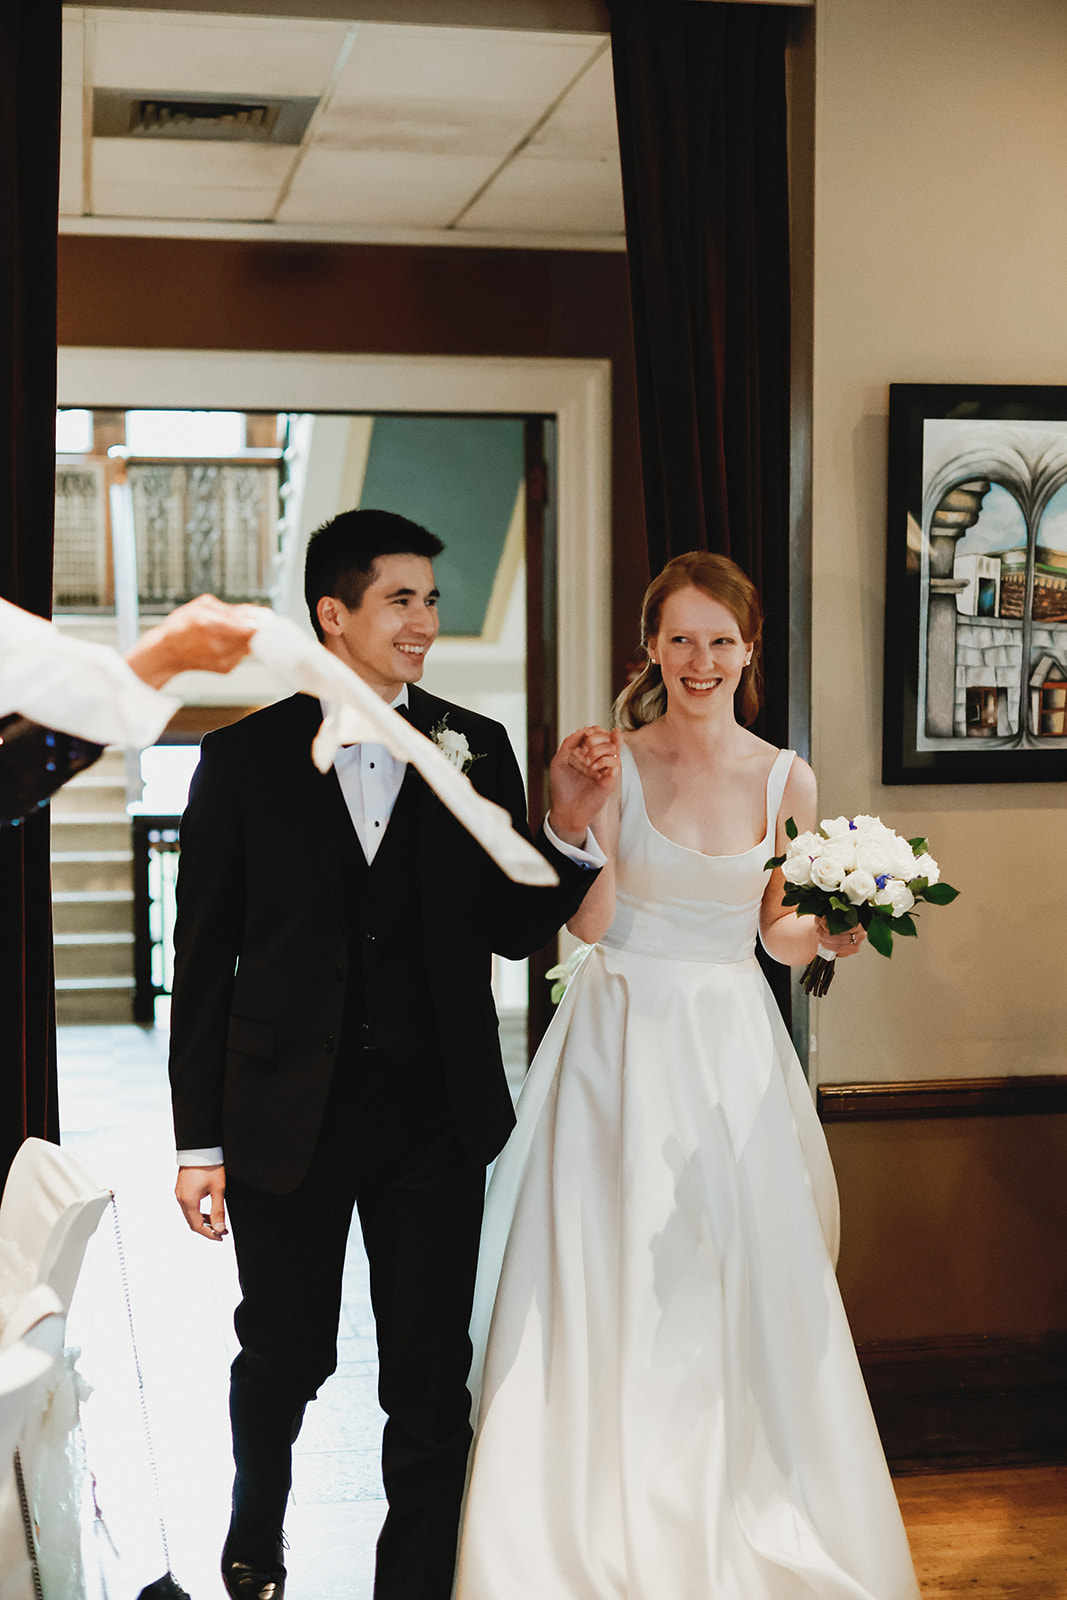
648,587,752,712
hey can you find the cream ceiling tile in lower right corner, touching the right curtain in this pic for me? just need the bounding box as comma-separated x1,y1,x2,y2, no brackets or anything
458,152,624,234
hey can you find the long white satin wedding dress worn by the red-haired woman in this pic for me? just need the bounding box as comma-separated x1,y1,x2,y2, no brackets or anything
456,749,918,1600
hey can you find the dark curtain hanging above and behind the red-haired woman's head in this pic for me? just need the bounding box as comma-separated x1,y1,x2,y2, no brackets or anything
609,0,789,744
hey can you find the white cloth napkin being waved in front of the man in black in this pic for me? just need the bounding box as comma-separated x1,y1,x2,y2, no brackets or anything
250,608,558,886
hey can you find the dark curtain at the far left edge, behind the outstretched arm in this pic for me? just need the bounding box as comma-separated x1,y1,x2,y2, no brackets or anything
0,0,61,1182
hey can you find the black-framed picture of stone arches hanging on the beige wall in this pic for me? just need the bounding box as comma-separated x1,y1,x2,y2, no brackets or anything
881,384,1067,784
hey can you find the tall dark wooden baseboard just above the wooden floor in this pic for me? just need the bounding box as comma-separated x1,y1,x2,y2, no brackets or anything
859,1331,1067,1474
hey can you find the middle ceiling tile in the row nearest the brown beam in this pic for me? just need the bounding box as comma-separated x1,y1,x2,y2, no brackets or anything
278,150,505,227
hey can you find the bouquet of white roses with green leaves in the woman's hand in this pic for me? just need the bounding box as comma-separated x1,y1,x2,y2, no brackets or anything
766,816,960,995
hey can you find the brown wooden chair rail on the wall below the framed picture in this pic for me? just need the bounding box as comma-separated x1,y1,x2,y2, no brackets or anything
817,1072,1067,1122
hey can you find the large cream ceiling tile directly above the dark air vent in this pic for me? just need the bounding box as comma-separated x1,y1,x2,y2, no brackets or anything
90,10,349,94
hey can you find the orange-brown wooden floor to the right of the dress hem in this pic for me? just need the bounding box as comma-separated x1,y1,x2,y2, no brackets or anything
894,1466,1067,1600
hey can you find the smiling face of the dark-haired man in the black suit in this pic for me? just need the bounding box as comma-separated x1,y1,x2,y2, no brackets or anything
318,555,440,701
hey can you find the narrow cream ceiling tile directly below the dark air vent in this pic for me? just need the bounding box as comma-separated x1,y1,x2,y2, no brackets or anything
93,139,296,193
